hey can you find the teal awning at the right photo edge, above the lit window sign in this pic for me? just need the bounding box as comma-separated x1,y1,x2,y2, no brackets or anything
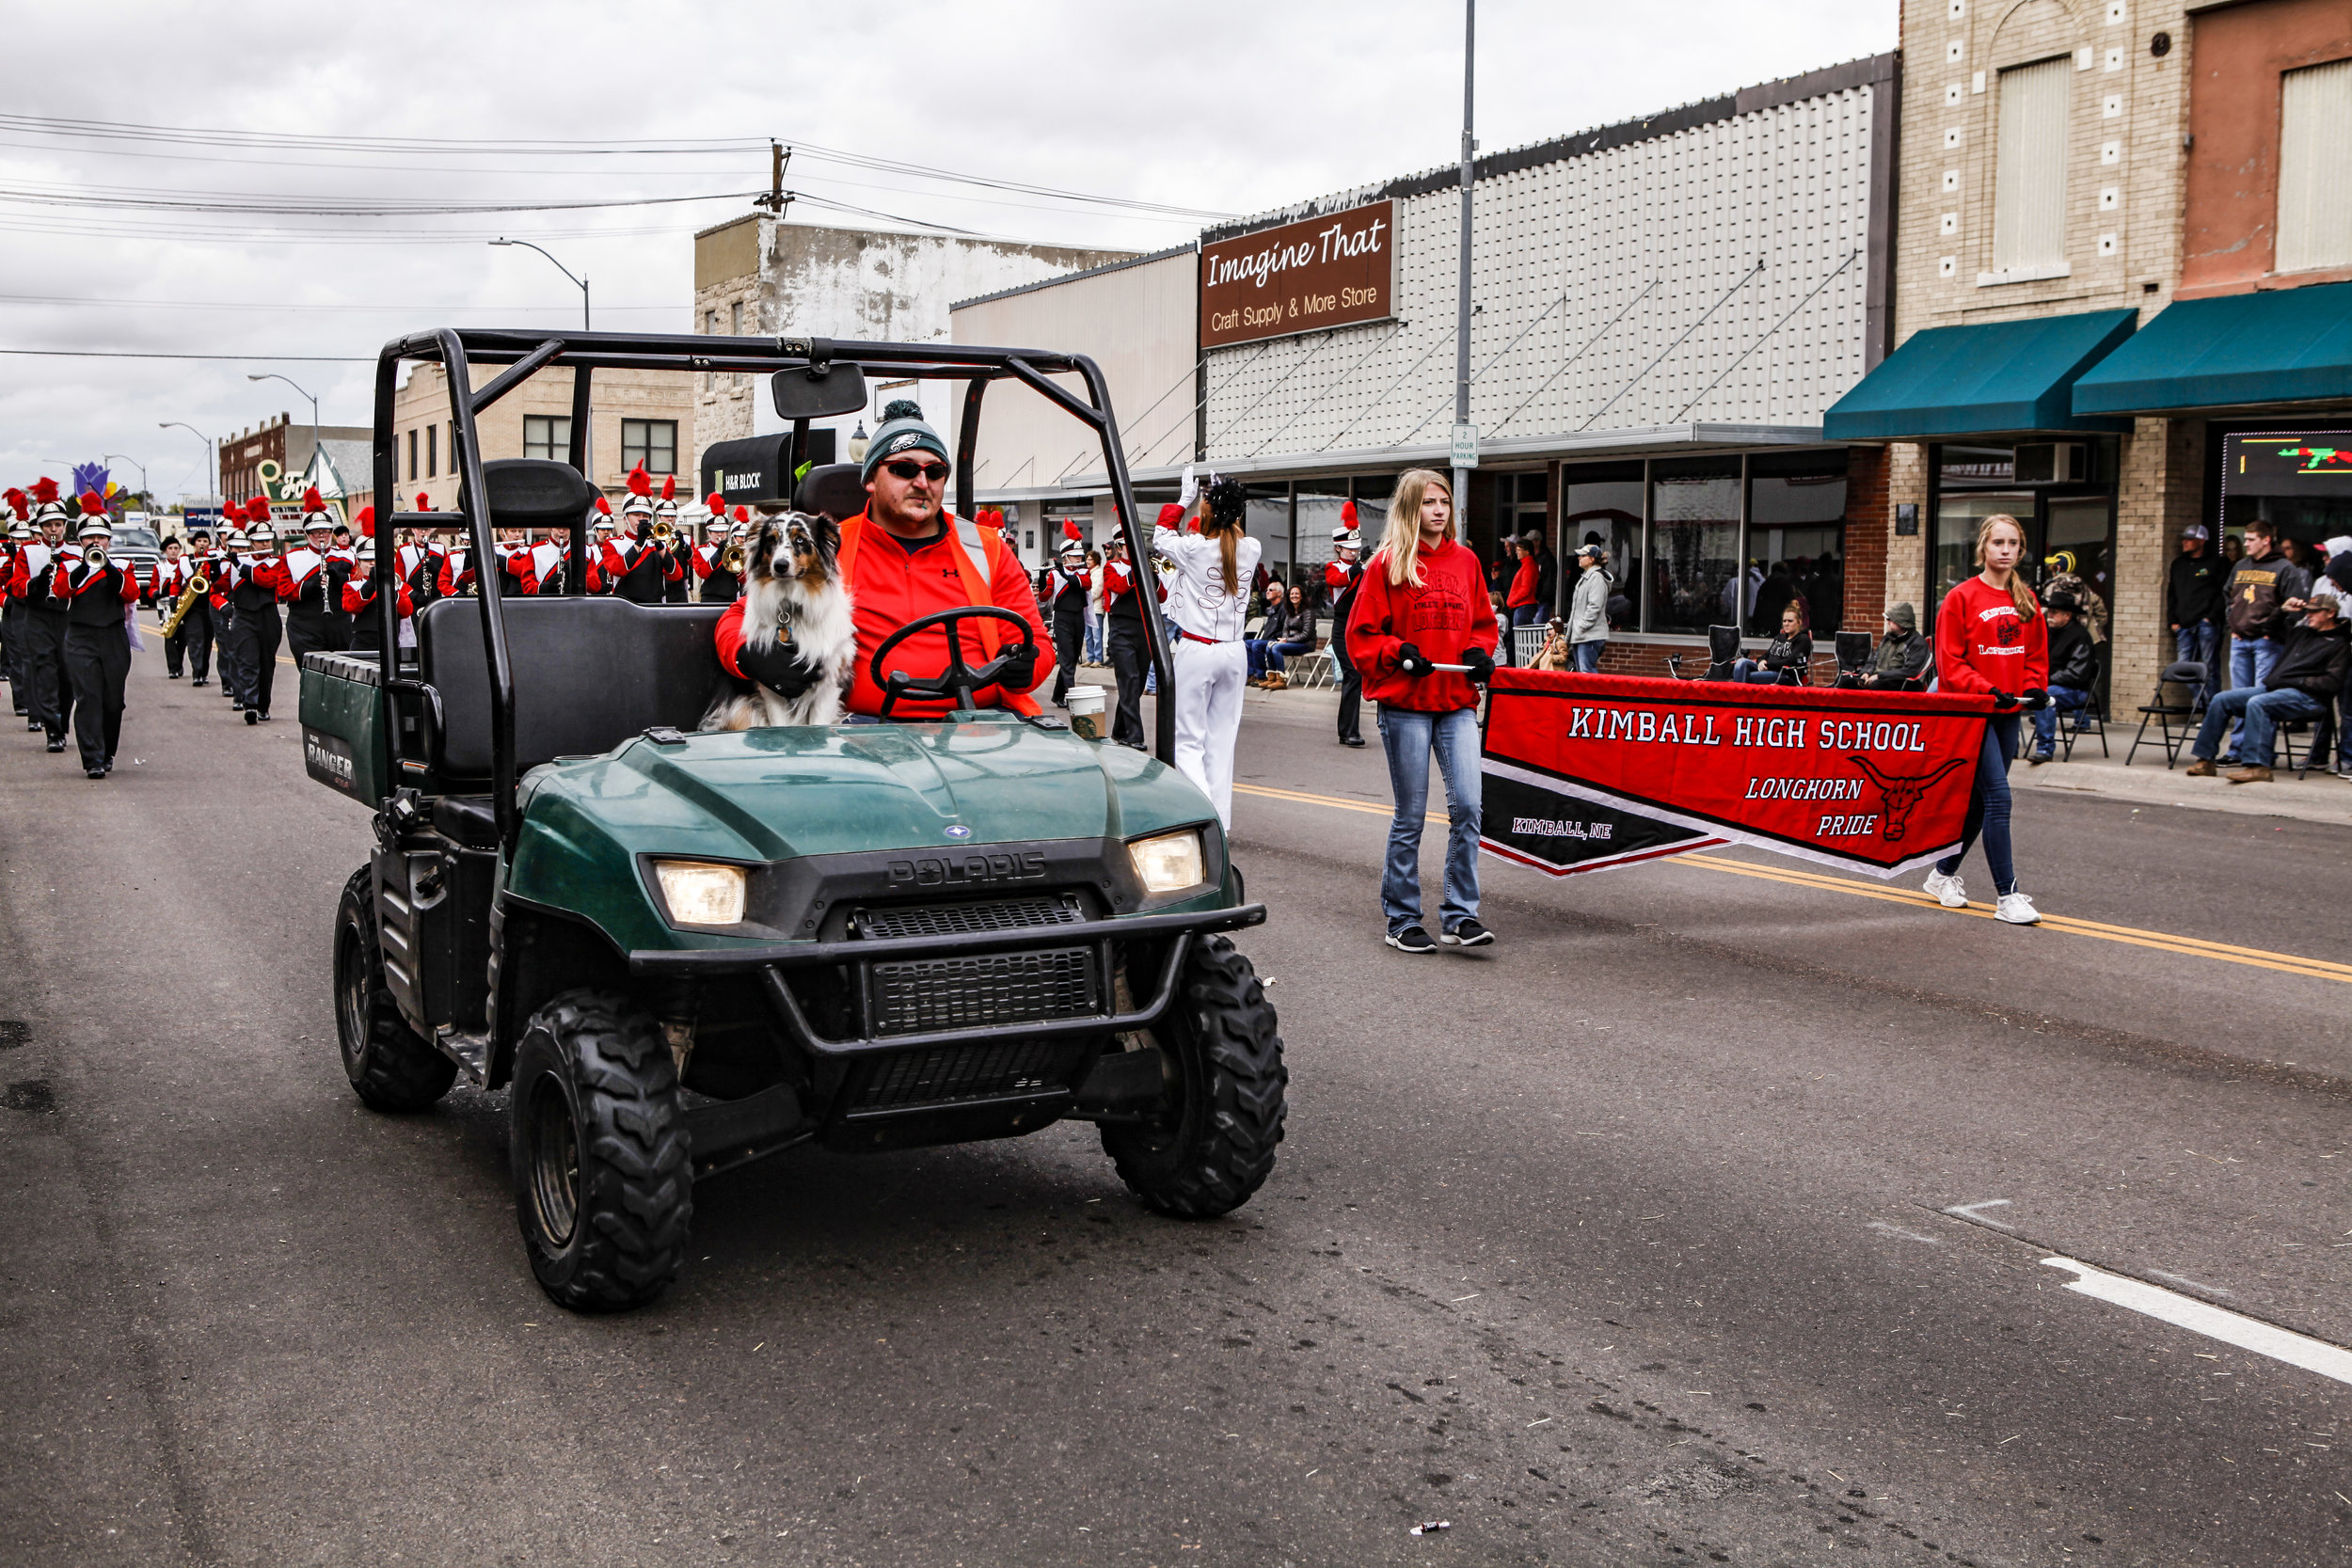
2074,282,2352,414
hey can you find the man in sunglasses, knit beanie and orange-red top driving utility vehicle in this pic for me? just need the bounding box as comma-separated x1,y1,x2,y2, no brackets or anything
718,397,1052,720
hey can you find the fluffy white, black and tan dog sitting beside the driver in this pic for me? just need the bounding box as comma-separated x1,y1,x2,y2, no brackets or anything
704,513,859,729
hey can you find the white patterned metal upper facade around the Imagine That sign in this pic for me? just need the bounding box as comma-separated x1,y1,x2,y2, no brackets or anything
1207,70,1894,461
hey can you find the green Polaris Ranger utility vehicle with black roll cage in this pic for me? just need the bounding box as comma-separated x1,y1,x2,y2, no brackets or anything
301,329,1289,1312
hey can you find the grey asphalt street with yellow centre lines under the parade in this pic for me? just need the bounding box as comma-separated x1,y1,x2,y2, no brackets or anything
0,629,2352,1568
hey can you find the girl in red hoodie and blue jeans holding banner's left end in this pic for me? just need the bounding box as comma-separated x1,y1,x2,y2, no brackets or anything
1345,467,1496,952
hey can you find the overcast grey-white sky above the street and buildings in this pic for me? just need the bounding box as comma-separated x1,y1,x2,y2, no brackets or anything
0,0,1899,500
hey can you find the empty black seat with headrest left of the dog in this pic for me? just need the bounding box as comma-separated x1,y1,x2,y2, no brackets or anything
417,458,724,784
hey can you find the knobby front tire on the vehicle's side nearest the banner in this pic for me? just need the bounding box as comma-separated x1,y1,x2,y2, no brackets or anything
1104,936,1292,1220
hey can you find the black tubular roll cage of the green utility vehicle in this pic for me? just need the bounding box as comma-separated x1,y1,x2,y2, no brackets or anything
370,326,1176,851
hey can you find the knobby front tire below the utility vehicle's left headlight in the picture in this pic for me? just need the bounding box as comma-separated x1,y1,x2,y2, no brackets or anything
508,990,694,1312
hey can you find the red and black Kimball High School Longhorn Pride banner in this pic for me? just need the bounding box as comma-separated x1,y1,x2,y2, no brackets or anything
1482,670,1993,877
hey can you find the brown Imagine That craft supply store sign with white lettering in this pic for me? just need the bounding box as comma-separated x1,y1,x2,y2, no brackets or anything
1200,202,1397,348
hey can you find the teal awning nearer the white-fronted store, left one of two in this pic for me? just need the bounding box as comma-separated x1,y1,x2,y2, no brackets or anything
1820,310,2140,442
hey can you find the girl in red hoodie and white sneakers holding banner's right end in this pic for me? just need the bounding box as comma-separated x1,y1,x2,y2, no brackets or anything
1927,513,2051,927
